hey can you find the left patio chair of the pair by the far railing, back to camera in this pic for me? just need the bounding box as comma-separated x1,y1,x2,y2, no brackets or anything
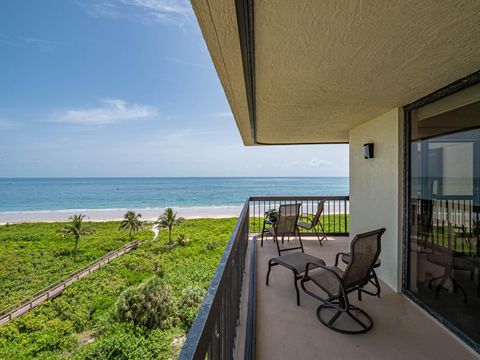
261,204,303,256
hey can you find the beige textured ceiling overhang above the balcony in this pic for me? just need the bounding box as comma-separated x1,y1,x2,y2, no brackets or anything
192,0,480,145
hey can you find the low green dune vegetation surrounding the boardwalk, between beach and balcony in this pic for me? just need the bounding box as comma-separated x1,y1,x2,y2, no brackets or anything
0,218,236,359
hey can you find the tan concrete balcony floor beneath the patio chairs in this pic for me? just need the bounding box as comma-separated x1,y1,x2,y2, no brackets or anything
256,237,480,360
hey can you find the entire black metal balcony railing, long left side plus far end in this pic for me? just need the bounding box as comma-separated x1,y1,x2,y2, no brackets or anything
179,196,350,360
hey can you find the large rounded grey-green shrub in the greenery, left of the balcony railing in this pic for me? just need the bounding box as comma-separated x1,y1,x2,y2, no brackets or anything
115,276,175,329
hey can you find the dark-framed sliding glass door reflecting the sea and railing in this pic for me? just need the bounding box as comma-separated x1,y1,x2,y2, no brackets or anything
405,84,480,350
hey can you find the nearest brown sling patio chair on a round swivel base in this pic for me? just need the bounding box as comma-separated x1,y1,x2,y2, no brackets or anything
301,228,385,334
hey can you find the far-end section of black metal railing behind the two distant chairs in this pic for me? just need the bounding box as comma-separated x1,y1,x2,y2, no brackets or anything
250,196,350,236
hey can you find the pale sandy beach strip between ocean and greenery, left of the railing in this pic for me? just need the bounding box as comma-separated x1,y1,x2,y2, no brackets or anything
0,206,242,225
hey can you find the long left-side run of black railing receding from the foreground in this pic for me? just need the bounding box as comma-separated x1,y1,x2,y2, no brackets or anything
179,200,249,360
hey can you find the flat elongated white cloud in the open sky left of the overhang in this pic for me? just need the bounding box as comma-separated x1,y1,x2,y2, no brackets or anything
51,99,157,125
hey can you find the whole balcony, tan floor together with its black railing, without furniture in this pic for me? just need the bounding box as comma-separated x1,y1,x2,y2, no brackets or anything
179,197,478,360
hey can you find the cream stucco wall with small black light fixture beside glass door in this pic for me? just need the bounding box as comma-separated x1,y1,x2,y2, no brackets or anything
349,109,402,291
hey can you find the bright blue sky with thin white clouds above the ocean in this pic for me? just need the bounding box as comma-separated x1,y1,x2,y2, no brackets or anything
0,0,348,177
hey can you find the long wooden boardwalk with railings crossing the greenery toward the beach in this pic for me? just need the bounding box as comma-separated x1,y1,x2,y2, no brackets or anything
0,240,142,325
